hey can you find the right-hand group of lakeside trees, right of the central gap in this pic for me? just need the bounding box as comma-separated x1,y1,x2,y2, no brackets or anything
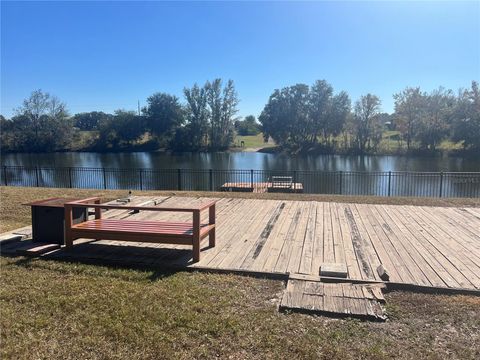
259,80,480,153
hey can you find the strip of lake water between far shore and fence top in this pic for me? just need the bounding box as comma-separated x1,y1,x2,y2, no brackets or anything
1,152,480,171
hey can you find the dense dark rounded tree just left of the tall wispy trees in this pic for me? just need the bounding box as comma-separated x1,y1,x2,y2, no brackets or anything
143,93,185,139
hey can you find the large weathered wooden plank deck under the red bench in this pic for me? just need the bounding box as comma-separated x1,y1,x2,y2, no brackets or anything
2,197,480,318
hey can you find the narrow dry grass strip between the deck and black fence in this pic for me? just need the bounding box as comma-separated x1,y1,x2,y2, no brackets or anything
0,186,480,233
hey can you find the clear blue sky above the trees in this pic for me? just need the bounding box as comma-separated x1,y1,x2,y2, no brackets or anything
0,1,480,117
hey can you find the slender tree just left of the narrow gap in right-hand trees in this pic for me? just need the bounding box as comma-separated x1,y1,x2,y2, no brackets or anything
354,94,383,152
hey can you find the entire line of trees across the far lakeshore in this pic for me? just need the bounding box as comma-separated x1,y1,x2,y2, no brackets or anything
0,79,480,153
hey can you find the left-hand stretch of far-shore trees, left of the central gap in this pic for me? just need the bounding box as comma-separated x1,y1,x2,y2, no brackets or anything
0,79,244,152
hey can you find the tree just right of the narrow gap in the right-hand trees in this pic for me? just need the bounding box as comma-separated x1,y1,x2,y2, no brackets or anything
393,87,426,149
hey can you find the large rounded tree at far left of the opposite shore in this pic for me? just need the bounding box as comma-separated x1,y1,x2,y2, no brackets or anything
12,90,72,151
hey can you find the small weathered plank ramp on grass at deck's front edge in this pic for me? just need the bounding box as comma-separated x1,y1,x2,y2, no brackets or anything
280,278,387,321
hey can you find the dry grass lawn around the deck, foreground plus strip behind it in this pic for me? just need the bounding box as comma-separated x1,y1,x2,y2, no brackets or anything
0,187,480,359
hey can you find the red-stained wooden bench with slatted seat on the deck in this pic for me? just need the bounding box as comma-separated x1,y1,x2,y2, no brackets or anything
65,197,216,262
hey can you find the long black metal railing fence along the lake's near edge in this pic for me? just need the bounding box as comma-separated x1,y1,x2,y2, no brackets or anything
0,166,480,197
